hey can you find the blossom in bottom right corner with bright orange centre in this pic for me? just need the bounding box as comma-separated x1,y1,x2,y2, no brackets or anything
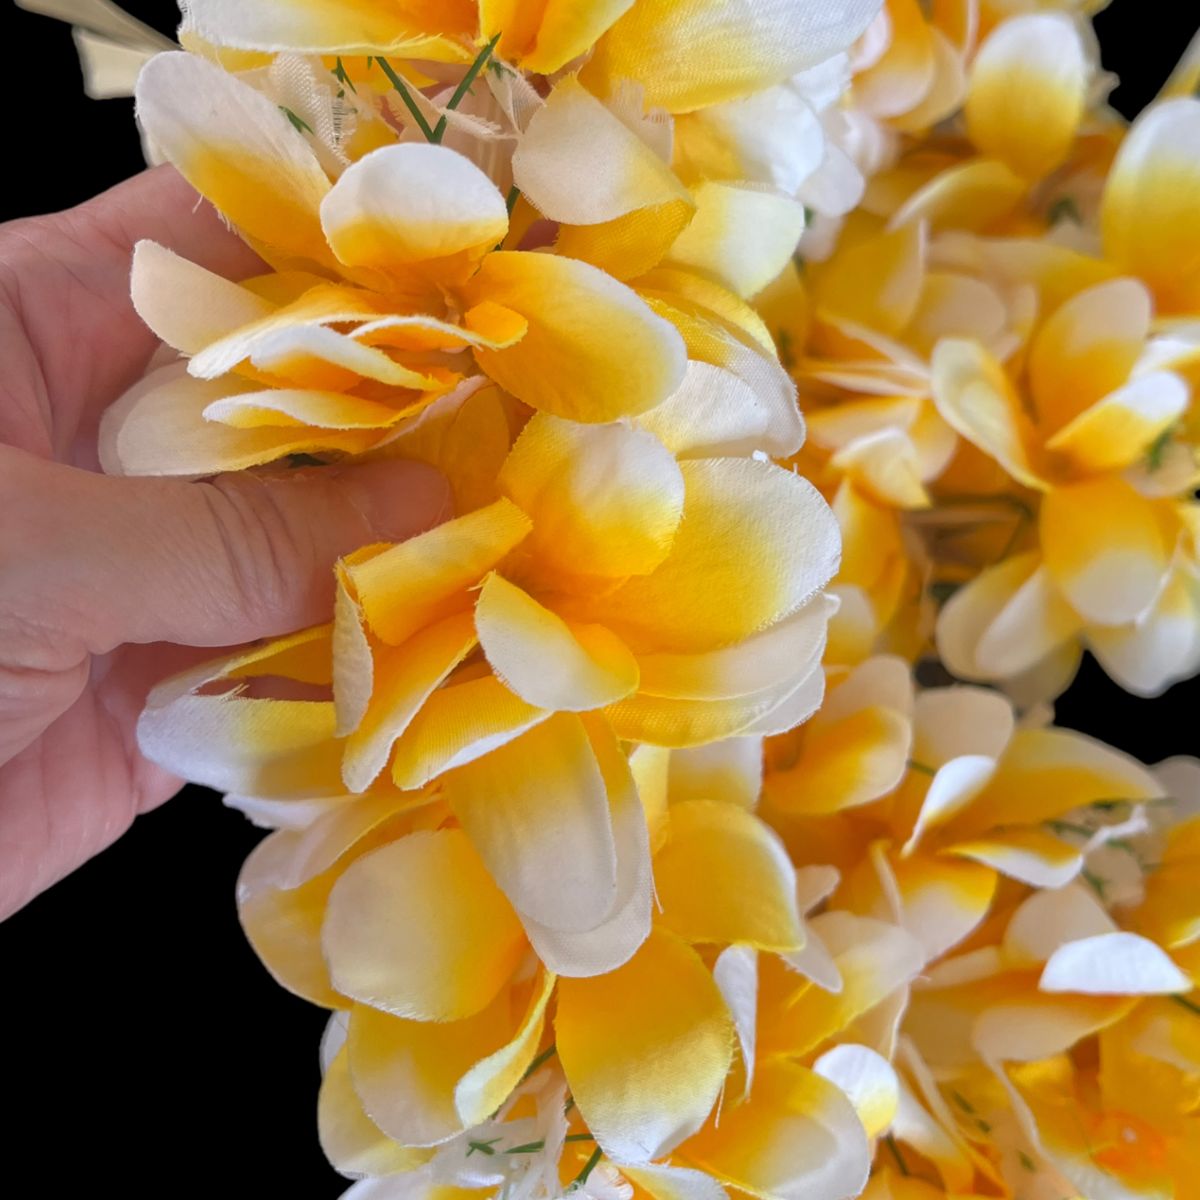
911,883,1200,1196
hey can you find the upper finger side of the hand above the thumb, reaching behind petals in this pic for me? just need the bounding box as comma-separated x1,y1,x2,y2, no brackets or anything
0,167,262,453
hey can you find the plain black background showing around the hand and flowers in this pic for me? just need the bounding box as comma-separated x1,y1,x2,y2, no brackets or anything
0,0,1200,1200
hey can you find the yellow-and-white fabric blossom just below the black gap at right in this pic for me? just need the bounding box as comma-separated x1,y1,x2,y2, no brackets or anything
764,659,1164,959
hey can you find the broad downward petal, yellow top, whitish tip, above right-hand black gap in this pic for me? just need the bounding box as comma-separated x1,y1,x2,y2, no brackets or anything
1038,476,1175,625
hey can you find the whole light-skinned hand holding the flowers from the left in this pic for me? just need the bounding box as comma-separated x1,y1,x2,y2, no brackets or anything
0,168,450,918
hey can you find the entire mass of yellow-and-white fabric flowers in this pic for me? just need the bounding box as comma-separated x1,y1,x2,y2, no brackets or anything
51,0,1200,1200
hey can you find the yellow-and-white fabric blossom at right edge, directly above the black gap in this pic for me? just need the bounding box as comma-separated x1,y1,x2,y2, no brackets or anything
934,267,1200,695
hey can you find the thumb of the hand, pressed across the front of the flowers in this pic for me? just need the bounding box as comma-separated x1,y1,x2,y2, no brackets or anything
0,449,451,670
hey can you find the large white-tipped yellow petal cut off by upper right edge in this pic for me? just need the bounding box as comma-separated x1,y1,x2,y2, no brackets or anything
1100,97,1200,313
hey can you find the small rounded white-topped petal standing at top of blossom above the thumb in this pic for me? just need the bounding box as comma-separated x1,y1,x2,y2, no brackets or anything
320,142,509,271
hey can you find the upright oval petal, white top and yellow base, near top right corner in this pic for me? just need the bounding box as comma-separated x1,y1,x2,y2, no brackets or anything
965,12,1090,179
